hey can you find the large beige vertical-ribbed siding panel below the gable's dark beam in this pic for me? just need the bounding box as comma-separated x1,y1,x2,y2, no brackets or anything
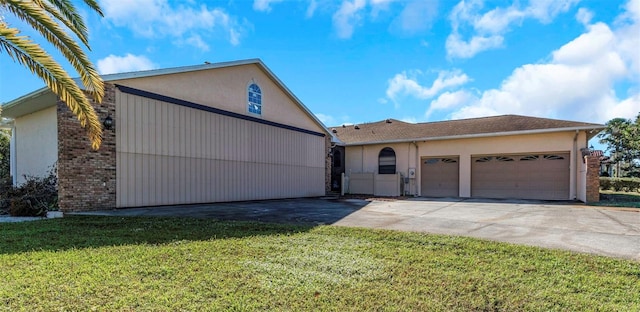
116,91,326,207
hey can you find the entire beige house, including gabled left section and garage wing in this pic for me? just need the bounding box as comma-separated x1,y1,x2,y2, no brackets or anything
0,59,604,211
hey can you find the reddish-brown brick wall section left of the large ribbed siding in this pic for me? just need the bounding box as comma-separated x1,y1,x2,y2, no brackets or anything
57,83,116,211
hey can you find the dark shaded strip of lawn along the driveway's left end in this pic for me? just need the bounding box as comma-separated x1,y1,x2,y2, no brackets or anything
0,216,313,254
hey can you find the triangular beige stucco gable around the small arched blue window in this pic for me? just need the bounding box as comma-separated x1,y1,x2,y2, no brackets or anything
113,64,324,132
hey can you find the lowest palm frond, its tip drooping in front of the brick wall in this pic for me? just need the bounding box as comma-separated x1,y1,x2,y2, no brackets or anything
0,23,102,150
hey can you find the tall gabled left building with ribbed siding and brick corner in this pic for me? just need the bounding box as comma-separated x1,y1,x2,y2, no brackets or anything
2,59,331,211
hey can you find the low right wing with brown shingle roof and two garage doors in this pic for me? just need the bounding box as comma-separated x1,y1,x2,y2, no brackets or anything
331,115,604,201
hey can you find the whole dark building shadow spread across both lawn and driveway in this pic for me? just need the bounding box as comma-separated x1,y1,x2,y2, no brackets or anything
0,199,369,254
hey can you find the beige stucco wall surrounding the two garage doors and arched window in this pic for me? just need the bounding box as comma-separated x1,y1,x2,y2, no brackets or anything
346,131,587,200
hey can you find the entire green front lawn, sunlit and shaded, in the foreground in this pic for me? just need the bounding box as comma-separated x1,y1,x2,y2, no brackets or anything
0,216,640,311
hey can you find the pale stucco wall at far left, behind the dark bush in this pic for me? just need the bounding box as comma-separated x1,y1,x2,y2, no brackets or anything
12,106,58,184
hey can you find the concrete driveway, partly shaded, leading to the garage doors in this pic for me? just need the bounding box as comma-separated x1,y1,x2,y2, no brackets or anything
70,198,640,260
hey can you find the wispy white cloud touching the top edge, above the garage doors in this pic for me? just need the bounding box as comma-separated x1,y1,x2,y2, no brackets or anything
445,0,579,58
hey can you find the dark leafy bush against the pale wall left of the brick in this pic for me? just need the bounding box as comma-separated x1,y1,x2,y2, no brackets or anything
0,166,58,217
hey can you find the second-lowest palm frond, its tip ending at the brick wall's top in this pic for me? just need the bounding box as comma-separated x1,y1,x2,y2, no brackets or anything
4,0,104,103
